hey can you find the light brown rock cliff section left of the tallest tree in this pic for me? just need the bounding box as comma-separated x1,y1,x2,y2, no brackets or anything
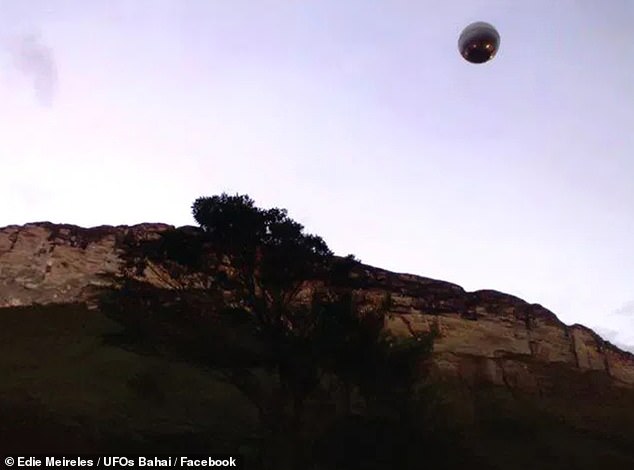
0,222,171,307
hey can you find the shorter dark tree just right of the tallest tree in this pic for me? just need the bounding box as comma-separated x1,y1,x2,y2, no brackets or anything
313,290,437,469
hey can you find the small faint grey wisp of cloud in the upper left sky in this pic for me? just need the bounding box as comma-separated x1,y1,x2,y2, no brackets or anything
8,33,58,107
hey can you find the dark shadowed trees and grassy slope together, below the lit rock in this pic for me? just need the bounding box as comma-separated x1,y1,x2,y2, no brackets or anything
0,194,634,469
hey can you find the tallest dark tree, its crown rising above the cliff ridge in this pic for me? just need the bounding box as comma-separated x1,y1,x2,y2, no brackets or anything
102,193,355,466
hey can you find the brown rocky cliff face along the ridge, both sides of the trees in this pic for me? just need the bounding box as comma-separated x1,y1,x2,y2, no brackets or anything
0,222,634,393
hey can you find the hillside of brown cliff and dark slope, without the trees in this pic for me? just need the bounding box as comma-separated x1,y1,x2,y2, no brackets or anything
0,222,634,468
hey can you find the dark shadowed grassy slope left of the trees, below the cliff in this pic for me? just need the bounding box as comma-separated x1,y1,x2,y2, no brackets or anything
0,305,255,451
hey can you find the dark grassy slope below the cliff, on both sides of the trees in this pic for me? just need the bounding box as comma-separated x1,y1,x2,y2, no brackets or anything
0,305,634,469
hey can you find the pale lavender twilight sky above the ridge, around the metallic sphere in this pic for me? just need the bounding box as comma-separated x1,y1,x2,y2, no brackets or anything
0,0,634,351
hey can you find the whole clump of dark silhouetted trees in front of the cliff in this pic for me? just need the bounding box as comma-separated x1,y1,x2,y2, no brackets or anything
97,194,444,468
